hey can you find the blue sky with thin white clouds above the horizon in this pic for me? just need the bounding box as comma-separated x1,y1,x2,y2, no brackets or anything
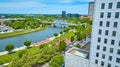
0,0,94,14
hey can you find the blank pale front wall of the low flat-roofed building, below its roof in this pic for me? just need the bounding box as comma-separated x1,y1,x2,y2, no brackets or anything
65,53,89,67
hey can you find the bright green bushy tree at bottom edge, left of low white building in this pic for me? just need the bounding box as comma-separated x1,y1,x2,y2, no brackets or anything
49,55,64,67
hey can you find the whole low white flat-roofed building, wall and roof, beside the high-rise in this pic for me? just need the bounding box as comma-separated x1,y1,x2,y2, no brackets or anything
65,48,89,67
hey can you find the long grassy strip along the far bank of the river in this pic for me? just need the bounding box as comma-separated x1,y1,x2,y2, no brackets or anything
0,26,48,39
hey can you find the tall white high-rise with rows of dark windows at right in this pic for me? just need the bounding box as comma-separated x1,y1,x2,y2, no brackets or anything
90,0,120,67
